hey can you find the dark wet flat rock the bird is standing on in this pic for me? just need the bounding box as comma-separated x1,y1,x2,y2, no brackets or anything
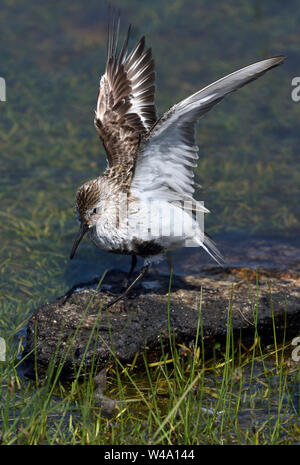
24,266,300,378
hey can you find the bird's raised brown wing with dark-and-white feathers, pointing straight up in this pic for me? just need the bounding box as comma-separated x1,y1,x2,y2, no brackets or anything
95,20,157,167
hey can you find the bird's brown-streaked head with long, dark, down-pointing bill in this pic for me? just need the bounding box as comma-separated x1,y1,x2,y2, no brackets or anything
70,179,101,260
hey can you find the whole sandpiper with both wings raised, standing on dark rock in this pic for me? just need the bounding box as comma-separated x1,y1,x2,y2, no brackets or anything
70,20,285,306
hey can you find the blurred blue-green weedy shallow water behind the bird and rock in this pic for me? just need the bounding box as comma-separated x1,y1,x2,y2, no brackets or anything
0,0,300,444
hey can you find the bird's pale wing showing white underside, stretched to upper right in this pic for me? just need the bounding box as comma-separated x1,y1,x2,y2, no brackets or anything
131,56,284,201
